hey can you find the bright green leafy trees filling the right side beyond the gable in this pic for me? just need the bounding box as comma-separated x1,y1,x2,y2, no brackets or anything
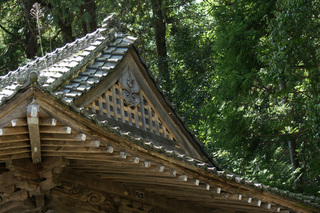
208,0,320,194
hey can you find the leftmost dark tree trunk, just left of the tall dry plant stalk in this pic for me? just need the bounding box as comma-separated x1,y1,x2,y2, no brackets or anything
23,0,38,58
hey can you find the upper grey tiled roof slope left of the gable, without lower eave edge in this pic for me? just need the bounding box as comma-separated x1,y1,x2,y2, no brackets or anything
0,16,136,104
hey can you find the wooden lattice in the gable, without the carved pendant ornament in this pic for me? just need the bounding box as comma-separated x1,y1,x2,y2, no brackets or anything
86,80,175,140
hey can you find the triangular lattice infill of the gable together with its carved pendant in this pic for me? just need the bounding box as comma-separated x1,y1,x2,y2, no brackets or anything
86,70,175,140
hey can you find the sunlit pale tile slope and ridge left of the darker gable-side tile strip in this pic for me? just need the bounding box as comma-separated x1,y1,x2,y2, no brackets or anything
0,15,136,104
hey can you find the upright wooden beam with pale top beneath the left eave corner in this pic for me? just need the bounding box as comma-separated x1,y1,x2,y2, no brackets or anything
27,103,41,163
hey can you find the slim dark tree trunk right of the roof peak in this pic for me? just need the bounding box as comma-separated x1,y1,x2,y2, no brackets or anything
152,0,170,90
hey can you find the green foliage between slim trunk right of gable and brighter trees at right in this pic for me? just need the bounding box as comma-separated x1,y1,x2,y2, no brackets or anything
168,4,214,135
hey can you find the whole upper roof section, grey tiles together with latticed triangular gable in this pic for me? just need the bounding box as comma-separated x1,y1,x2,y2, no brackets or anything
0,16,213,163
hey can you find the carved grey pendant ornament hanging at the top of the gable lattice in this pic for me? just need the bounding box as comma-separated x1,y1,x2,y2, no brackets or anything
119,71,140,106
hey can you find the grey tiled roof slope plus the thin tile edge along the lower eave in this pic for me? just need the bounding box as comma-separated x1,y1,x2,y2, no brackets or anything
0,17,320,208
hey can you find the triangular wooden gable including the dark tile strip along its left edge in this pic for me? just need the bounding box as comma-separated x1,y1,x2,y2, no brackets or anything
58,42,210,162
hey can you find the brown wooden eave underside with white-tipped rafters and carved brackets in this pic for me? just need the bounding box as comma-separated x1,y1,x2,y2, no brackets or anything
0,86,319,212
